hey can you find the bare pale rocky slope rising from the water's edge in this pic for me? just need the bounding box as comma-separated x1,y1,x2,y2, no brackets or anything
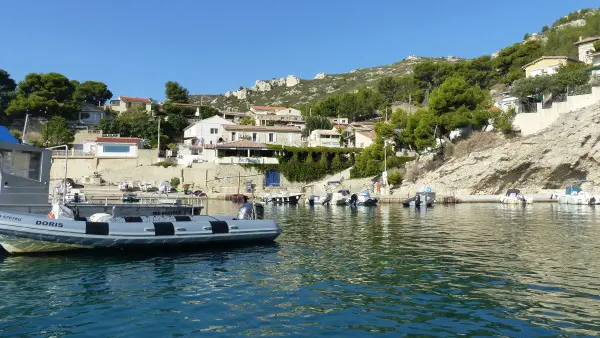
395,103,600,196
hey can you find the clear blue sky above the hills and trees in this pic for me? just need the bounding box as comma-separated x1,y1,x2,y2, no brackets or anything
0,0,599,100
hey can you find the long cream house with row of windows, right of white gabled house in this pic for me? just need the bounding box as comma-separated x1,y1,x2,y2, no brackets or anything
220,124,302,146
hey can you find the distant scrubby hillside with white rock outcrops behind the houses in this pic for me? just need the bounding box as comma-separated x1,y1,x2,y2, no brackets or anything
191,56,460,111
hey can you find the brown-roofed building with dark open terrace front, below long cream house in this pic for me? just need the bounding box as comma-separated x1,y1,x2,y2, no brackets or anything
215,140,279,164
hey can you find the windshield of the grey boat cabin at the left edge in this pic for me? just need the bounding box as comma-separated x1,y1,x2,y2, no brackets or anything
0,149,42,181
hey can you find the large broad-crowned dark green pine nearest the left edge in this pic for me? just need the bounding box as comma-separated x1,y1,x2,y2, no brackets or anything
6,73,80,119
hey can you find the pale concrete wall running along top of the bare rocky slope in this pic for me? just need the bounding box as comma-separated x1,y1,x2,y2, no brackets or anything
513,87,600,136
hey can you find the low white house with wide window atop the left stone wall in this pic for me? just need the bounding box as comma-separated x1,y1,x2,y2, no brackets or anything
83,137,142,158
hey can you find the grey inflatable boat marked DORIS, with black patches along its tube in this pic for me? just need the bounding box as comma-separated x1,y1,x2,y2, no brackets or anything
0,203,282,254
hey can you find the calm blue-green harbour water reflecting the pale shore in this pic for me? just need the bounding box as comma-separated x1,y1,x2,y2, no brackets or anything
0,202,600,337
